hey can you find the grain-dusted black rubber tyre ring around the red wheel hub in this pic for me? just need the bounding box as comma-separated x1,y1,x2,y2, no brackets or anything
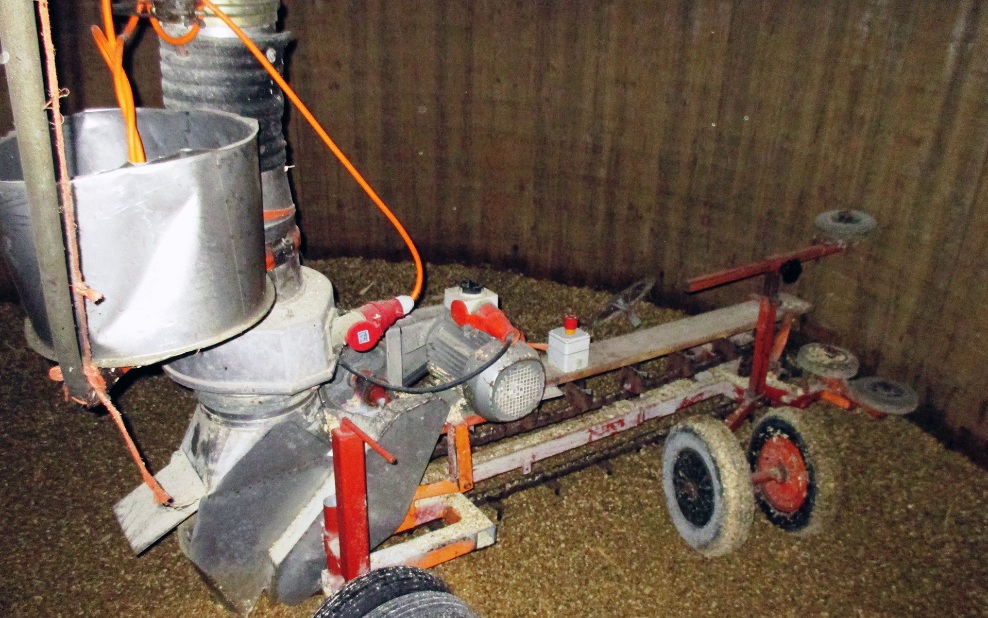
748,407,838,536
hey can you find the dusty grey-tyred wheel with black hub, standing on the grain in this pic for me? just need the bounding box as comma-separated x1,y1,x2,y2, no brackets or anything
662,416,755,557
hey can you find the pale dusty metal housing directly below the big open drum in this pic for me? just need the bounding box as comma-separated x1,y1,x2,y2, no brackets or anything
165,268,336,395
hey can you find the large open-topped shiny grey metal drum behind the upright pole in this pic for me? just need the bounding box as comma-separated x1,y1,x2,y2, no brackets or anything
0,109,274,367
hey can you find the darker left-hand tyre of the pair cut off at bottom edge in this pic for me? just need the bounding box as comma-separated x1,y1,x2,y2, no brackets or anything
312,566,450,618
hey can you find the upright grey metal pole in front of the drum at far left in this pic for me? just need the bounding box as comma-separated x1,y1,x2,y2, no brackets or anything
0,0,89,400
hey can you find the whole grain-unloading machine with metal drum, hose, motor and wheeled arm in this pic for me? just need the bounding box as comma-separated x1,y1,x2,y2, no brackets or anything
0,0,909,616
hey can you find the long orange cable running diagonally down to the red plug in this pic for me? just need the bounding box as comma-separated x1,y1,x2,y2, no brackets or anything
202,0,425,300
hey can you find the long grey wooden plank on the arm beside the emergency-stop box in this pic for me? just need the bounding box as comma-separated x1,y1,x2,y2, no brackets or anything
546,294,811,386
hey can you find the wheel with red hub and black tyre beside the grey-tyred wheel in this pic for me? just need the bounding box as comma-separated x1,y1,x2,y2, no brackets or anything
748,408,837,535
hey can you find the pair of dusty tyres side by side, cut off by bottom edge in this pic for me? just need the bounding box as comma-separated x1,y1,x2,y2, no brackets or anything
313,566,476,618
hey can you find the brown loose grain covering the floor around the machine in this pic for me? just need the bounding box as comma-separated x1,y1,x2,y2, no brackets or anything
0,260,988,618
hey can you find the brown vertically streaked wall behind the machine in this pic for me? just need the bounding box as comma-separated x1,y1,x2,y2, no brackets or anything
0,0,988,462
